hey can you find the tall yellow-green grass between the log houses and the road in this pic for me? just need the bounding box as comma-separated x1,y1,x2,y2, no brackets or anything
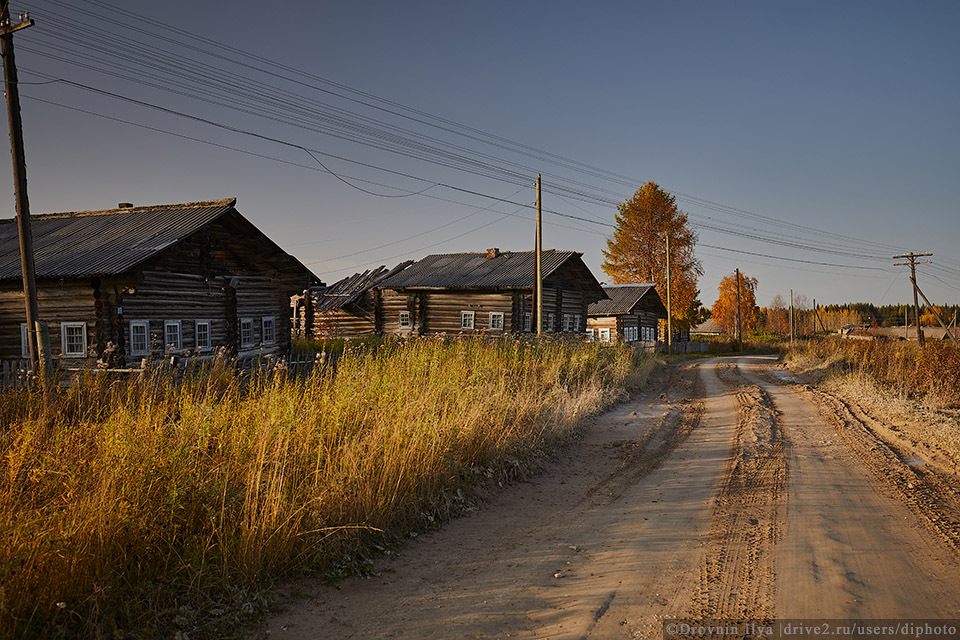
0,340,652,638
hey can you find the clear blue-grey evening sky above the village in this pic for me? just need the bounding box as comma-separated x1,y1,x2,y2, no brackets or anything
0,0,960,306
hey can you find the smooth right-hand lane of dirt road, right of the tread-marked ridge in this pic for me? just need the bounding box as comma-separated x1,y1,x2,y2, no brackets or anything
738,356,960,620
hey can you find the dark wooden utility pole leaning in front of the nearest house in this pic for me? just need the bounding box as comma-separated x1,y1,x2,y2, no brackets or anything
0,2,40,374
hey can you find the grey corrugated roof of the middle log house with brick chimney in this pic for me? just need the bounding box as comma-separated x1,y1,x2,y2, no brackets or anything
377,249,586,289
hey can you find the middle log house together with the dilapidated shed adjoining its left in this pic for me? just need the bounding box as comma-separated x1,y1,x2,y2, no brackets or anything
310,249,604,337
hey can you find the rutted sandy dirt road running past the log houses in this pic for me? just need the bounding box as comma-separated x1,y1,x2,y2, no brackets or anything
269,357,960,640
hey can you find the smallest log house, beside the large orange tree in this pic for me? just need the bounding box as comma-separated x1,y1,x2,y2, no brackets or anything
587,284,667,343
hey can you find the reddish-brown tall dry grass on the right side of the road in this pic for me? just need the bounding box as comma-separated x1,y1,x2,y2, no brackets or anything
787,337,960,408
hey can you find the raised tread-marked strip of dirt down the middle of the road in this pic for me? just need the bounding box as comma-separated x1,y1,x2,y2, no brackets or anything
691,364,787,621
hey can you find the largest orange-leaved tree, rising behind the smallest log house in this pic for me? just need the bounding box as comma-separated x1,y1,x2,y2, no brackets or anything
601,182,703,328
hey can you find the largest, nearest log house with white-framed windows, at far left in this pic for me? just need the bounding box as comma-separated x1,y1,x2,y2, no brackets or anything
0,199,318,368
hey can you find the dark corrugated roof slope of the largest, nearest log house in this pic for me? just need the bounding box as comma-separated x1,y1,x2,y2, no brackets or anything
0,198,237,280
